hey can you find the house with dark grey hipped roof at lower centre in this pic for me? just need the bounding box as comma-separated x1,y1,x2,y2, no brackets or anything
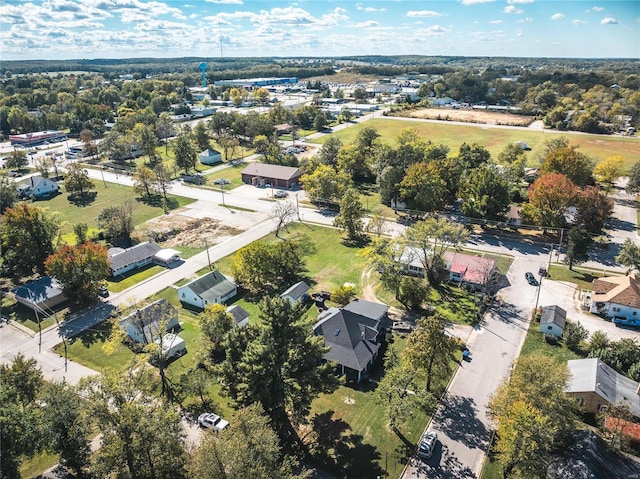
313,300,389,382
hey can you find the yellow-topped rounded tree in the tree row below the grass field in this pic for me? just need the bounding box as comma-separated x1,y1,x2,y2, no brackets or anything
399,162,447,212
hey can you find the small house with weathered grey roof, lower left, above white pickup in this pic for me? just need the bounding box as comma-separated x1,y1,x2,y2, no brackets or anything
120,298,178,344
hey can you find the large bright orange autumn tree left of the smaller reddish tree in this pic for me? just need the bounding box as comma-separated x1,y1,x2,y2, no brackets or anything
521,173,578,227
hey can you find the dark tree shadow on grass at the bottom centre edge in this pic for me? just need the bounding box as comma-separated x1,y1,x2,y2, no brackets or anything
310,411,384,478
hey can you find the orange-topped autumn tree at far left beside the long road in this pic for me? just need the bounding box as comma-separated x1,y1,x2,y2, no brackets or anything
45,241,109,304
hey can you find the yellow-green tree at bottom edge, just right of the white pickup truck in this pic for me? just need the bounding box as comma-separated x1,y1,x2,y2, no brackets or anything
189,404,302,479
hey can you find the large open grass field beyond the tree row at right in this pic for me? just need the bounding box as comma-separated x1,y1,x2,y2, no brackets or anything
310,118,640,169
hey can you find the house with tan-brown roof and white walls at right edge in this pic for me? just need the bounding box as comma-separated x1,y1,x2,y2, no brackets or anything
589,276,640,320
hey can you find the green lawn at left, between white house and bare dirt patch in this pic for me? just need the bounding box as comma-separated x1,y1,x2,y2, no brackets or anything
34,181,195,233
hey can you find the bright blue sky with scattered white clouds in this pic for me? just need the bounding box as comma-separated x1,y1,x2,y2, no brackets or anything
0,0,640,60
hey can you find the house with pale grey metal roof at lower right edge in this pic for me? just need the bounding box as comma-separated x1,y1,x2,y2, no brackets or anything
566,358,640,417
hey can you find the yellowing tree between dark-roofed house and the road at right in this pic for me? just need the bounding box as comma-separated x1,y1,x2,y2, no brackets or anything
404,313,458,393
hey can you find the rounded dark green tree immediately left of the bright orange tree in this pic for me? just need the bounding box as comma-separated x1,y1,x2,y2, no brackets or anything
460,165,511,221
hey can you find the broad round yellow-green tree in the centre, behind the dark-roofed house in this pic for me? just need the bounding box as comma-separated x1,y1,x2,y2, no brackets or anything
231,241,305,295
